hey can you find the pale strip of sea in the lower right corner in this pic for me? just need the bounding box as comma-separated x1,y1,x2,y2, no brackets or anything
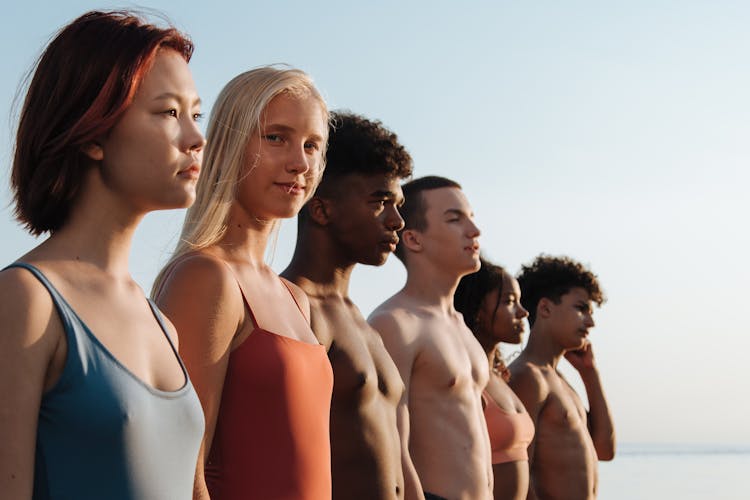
598,443,750,500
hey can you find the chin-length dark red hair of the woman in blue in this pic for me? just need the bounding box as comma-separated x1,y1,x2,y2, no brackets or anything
11,11,193,235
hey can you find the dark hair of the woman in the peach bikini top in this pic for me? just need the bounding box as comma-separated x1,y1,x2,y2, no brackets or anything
453,257,505,334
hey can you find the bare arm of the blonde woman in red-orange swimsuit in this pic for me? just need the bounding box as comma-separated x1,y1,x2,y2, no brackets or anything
155,256,243,500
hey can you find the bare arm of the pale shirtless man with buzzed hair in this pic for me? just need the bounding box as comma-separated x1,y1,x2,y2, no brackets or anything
368,314,424,500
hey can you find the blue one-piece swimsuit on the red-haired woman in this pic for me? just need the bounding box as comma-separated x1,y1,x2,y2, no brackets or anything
8,263,204,500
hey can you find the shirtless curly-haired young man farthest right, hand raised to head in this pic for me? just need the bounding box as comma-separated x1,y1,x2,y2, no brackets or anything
510,255,615,500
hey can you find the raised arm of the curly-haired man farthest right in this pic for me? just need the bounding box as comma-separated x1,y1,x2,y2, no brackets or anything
565,343,615,460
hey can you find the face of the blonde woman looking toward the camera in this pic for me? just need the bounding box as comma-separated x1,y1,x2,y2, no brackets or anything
237,94,328,220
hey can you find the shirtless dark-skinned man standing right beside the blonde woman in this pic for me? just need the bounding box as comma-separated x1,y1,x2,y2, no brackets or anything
282,113,422,500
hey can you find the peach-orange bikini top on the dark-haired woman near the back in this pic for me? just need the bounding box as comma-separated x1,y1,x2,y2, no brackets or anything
482,391,534,464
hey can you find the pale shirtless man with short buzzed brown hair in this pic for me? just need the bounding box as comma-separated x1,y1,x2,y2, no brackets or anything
369,177,492,500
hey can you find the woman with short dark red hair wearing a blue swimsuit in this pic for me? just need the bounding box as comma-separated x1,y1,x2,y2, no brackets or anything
0,12,205,500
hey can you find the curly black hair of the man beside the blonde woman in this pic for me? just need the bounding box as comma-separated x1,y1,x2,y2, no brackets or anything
318,111,412,193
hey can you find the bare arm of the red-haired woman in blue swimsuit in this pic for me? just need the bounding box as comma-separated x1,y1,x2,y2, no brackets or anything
0,269,65,499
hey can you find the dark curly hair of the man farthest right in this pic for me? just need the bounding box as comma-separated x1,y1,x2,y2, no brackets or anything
517,254,607,325
